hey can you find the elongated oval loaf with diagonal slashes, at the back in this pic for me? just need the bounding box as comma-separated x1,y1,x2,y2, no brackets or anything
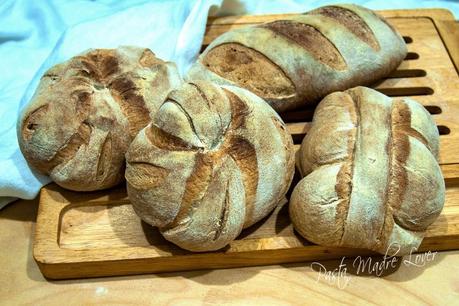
187,5,407,111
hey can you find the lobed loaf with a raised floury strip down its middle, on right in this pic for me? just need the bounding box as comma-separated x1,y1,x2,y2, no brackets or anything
290,87,445,255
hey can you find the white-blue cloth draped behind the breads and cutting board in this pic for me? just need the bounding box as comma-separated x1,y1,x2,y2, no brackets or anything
0,0,459,208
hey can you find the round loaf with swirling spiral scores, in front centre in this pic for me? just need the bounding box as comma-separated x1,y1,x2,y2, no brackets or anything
126,82,294,251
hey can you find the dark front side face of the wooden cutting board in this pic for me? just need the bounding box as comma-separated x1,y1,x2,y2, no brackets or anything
34,237,459,279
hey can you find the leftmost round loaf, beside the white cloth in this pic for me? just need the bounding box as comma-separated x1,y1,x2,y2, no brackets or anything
18,47,180,191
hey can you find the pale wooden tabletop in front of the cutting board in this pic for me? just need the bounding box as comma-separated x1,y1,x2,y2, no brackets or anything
0,199,459,306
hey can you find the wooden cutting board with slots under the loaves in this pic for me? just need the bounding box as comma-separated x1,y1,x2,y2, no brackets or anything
33,9,459,279
